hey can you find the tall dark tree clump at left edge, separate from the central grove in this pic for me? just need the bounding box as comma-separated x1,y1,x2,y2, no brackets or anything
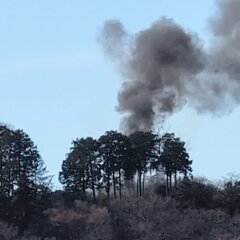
0,126,49,230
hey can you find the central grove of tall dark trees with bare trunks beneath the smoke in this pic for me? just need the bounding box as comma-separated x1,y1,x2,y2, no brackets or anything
59,131,192,201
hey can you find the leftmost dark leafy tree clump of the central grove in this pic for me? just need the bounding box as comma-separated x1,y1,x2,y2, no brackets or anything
59,137,101,201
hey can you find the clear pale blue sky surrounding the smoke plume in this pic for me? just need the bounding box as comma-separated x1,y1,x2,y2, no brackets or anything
0,0,240,186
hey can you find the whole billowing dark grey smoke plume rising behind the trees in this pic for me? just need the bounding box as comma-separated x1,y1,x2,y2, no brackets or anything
100,0,240,133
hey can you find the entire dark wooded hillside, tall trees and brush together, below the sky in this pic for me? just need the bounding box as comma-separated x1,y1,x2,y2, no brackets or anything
0,125,240,240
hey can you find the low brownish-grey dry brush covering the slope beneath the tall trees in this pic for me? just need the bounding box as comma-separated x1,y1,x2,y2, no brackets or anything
0,179,240,240
